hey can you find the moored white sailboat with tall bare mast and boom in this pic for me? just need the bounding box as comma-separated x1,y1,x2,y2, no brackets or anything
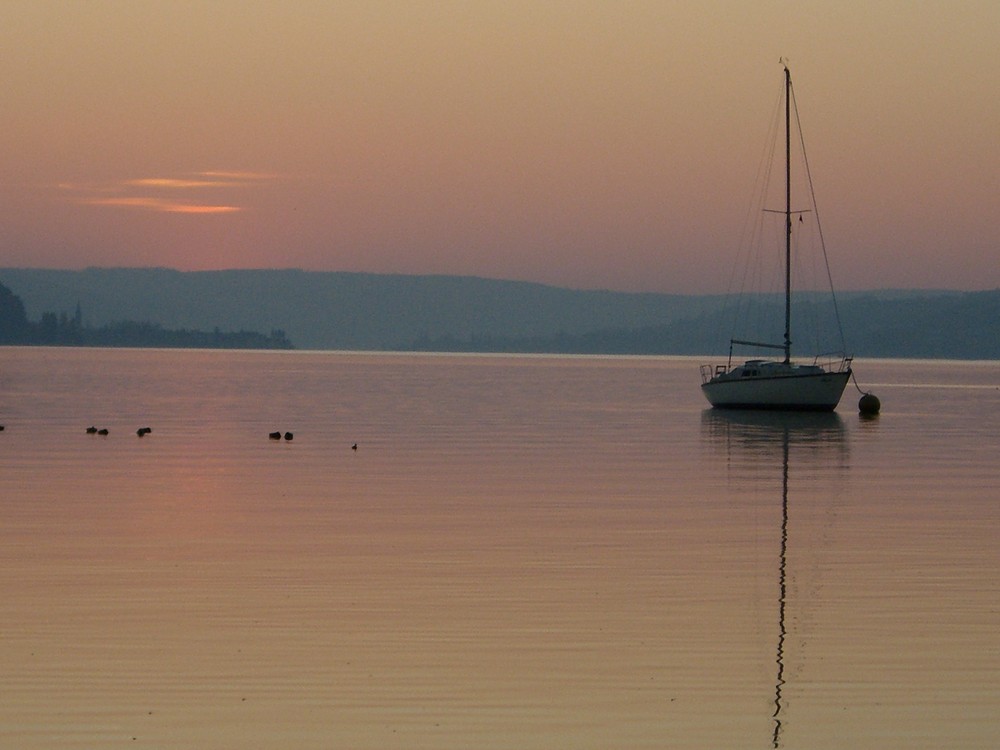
701,65,852,411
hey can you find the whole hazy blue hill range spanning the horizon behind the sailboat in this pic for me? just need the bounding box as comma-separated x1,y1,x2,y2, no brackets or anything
0,268,1000,359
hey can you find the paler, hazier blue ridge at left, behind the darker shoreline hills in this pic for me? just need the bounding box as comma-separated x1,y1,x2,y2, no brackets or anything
0,268,712,350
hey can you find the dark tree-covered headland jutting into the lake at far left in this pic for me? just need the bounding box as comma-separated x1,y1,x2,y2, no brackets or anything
0,284,293,349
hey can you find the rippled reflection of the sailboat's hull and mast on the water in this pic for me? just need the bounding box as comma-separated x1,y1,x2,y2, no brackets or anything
702,409,848,748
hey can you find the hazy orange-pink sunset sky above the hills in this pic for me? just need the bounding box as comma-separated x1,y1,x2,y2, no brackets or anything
0,0,1000,293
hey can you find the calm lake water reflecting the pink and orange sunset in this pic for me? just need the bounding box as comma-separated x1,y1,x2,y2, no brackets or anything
0,348,1000,750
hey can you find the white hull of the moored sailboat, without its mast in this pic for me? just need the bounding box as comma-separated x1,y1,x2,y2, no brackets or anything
701,368,851,411
